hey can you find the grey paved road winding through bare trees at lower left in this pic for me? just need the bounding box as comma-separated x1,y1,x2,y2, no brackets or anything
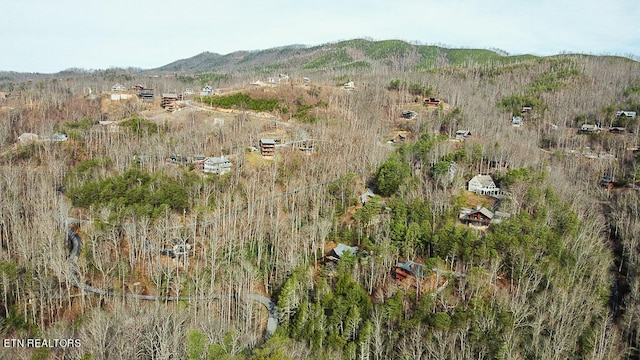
67,219,278,338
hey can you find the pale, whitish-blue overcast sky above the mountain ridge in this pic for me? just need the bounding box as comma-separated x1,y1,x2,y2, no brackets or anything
0,0,640,73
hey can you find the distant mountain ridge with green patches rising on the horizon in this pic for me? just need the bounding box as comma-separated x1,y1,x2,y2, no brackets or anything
152,39,536,73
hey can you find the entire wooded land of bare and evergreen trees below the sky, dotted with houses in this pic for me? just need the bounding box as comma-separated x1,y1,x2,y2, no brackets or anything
0,40,640,359
